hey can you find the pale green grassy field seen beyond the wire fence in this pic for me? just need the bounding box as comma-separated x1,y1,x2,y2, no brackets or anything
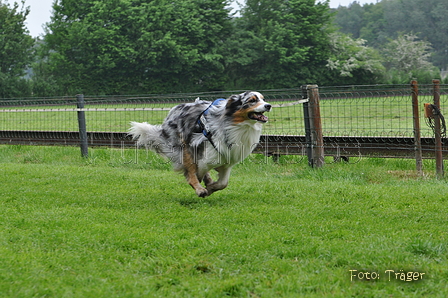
0,95,448,137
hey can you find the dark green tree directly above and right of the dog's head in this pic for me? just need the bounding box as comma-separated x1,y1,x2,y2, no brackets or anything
226,0,331,89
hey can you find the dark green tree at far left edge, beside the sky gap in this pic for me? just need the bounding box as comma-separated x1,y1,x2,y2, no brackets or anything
0,1,34,98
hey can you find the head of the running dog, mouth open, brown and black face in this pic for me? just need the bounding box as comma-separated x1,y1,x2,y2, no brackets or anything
226,91,272,123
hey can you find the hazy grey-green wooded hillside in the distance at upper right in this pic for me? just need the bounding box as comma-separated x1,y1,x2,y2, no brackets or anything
335,0,448,69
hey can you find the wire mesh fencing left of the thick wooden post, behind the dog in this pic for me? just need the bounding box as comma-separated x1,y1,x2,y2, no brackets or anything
0,89,304,135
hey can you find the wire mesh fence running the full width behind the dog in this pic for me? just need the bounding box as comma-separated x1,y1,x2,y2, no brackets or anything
0,85,448,161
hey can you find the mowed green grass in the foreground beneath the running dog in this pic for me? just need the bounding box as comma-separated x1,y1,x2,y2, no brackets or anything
0,145,448,297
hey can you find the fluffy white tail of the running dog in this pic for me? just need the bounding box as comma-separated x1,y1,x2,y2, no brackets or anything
129,122,164,151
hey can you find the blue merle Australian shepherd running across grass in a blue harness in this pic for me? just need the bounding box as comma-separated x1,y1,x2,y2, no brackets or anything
129,91,272,197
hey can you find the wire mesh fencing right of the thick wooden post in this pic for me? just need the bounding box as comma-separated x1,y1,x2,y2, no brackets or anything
319,85,448,138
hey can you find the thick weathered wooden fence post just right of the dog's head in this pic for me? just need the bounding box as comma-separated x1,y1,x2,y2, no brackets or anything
307,85,325,168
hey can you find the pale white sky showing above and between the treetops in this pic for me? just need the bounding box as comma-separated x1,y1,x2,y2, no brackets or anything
6,0,377,37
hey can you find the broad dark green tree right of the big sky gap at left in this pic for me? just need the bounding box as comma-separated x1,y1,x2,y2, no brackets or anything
39,0,230,94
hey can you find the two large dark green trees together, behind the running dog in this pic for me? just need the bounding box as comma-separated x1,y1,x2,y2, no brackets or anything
36,0,332,94
